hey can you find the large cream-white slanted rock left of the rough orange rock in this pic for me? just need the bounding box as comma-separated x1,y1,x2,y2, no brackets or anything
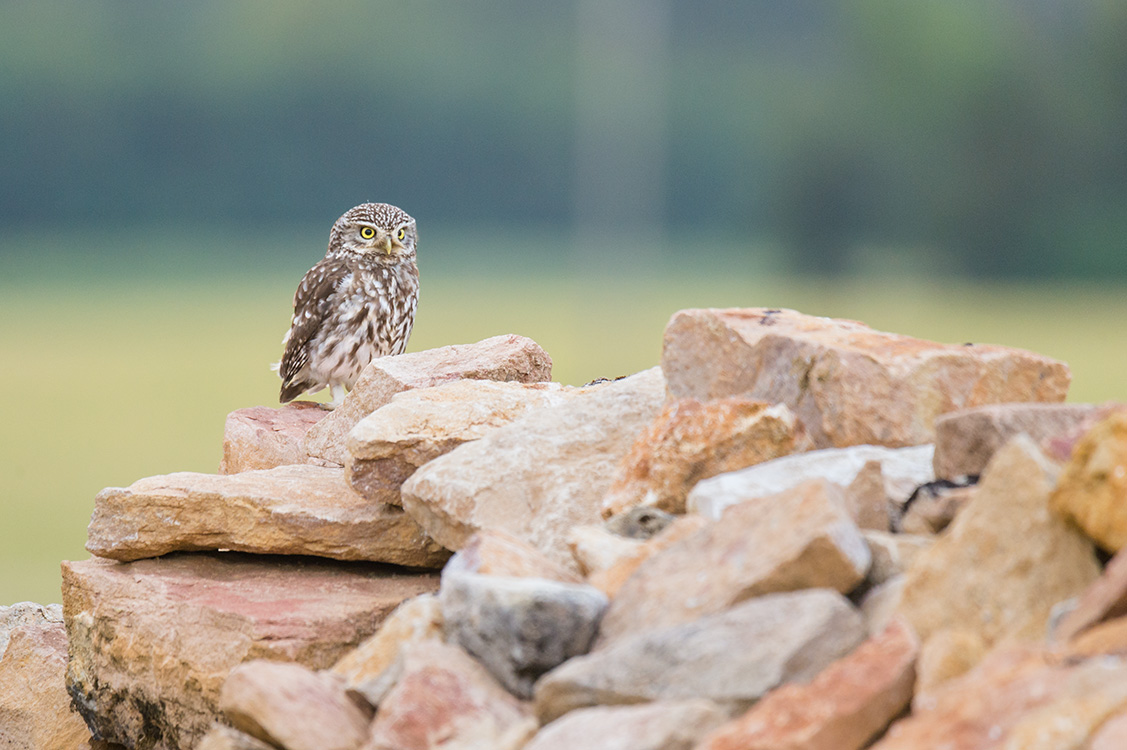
402,368,665,571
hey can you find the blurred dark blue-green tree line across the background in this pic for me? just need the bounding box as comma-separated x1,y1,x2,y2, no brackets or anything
0,0,1127,277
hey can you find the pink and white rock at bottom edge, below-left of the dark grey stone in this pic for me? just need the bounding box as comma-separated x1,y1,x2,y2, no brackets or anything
364,641,536,750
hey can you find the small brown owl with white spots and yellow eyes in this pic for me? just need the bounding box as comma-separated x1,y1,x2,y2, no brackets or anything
277,203,419,407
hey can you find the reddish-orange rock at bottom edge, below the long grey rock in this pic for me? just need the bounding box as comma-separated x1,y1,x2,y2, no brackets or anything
696,620,919,750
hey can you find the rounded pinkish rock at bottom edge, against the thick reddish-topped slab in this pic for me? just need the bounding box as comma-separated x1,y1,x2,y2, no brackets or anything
219,660,372,750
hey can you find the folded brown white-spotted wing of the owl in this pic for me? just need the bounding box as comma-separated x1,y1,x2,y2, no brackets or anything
278,258,349,404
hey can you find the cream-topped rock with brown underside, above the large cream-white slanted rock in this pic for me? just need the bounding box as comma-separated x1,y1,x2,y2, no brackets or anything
347,380,579,505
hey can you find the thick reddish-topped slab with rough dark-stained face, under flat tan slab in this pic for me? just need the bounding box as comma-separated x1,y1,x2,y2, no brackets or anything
62,553,438,750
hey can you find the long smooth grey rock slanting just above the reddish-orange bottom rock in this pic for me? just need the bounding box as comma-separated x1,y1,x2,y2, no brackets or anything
535,589,866,723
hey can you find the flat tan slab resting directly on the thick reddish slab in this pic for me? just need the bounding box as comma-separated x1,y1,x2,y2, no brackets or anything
86,465,450,567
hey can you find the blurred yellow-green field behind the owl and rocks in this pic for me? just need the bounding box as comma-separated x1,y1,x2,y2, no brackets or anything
0,248,1127,605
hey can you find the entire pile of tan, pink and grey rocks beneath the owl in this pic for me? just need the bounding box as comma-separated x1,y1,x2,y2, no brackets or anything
0,309,1127,750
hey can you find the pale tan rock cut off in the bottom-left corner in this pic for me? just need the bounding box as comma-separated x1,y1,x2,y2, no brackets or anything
0,602,90,750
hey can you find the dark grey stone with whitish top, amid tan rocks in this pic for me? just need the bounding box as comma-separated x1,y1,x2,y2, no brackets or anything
438,572,606,698
